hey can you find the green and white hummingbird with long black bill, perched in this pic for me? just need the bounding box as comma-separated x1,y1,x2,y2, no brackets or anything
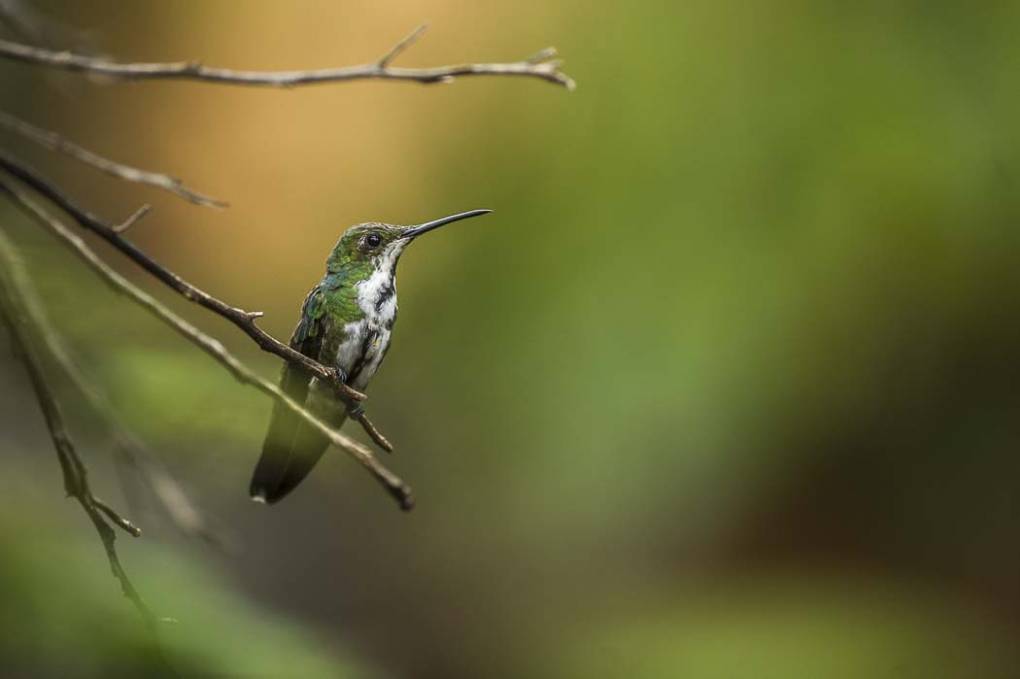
250,210,492,503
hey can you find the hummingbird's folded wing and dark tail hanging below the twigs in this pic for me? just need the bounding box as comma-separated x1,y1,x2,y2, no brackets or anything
250,286,344,503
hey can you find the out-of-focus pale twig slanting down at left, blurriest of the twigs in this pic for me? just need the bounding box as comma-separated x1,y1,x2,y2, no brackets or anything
0,228,222,546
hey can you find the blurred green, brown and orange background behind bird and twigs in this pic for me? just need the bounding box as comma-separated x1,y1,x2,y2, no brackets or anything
0,0,1020,679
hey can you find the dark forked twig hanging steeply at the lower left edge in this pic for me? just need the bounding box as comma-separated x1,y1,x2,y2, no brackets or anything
0,238,156,629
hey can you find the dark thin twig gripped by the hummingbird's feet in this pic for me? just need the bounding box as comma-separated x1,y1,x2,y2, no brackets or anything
0,151,365,401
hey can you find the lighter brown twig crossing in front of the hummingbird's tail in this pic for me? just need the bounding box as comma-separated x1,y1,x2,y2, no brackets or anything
0,177,414,510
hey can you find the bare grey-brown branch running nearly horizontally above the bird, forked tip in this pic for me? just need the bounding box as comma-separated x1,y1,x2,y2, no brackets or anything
0,30,574,90
